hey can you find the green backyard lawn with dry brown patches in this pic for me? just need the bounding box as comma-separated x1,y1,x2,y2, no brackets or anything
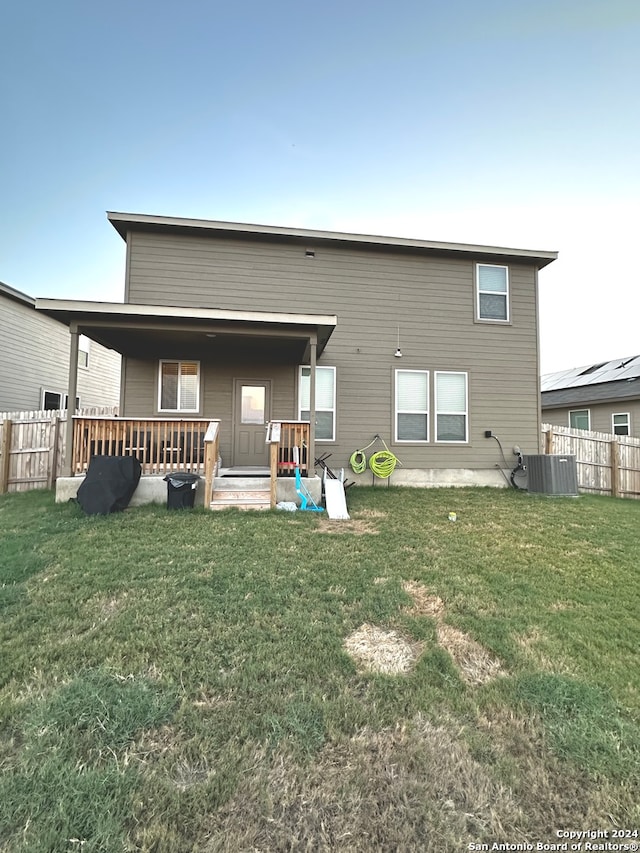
0,487,640,853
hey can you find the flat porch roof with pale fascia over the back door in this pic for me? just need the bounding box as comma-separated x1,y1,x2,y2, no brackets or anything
35,299,338,363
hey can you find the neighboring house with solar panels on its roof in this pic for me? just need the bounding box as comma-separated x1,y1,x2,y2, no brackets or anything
541,355,640,438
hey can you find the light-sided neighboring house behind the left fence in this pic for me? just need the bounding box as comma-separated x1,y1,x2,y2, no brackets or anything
0,282,121,412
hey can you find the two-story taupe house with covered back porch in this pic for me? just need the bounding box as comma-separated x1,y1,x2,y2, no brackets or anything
37,213,557,485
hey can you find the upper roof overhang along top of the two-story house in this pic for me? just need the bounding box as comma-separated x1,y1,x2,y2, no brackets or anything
107,211,558,269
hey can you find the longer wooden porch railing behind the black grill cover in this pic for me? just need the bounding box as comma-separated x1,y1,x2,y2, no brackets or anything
71,416,218,474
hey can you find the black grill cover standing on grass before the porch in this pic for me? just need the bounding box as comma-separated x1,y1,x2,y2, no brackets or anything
77,456,141,515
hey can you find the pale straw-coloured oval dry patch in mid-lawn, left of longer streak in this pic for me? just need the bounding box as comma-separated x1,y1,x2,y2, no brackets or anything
344,622,422,675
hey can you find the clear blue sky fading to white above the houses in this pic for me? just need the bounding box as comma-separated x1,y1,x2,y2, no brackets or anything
0,0,640,372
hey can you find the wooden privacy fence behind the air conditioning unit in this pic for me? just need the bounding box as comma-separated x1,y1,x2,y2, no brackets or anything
542,424,640,499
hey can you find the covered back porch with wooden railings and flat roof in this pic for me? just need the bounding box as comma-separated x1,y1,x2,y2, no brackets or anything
36,299,337,490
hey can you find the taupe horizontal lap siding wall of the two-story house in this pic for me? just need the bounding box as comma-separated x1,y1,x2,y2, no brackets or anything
124,233,539,469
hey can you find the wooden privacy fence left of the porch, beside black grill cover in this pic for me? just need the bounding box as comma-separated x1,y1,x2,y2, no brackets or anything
0,406,117,494
